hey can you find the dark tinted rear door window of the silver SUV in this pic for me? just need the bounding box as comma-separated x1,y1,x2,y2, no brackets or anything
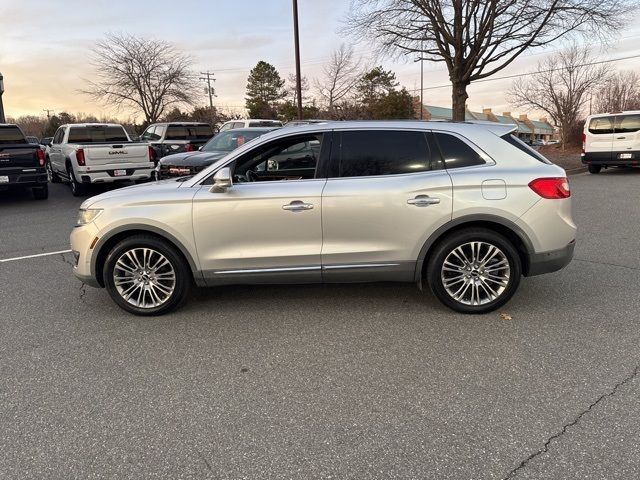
339,130,431,177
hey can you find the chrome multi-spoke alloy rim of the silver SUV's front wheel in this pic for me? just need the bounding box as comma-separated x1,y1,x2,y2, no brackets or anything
113,248,176,308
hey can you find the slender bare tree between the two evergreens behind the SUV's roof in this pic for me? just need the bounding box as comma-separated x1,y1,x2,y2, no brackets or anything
314,43,364,115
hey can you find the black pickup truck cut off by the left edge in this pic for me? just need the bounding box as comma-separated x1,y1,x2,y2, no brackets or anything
0,123,49,200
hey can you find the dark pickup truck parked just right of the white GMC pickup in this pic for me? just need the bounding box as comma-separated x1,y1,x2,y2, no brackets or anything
140,122,213,162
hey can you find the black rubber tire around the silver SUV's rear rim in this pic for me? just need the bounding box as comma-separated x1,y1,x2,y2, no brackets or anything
426,228,522,313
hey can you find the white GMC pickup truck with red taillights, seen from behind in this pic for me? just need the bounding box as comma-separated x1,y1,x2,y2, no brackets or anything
46,123,155,196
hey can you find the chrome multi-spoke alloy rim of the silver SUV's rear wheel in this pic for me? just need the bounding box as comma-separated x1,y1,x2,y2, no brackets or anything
440,242,511,305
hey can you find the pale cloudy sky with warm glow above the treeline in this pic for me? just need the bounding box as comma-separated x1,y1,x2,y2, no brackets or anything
0,0,640,121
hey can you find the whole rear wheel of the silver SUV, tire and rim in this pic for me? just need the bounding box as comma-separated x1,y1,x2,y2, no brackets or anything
427,228,522,313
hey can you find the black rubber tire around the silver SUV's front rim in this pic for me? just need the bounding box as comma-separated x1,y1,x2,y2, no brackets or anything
103,234,193,316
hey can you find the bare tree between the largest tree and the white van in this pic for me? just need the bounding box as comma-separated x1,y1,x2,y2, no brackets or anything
507,45,607,147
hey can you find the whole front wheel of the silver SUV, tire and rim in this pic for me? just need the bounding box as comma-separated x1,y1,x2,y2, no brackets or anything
103,235,192,315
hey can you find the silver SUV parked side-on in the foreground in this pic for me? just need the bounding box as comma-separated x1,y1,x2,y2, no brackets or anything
71,122,576,315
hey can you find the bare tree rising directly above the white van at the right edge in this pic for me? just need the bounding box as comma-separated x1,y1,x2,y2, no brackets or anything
593,71,640,113
